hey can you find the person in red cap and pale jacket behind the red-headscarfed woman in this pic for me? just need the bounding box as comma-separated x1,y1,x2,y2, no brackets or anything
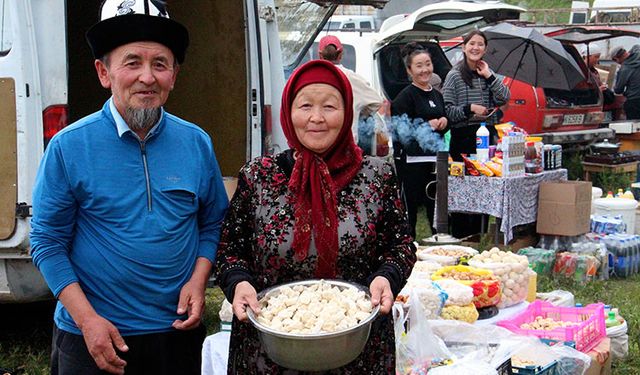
318,35,383,144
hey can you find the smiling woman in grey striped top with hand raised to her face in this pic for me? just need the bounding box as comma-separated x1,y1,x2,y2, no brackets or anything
442,30,510,238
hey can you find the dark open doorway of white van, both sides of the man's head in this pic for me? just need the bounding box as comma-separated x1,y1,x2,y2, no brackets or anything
67,0,248,176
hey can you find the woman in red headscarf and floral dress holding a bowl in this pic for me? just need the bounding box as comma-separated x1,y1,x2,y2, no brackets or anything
215,60,416,374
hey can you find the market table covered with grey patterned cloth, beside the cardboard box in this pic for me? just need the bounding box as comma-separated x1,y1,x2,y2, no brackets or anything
435,169,567,245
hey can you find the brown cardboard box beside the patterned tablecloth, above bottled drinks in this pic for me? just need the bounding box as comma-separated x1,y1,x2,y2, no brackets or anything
536,181,591,236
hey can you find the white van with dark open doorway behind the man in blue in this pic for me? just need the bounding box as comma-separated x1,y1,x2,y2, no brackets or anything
0,0,380,303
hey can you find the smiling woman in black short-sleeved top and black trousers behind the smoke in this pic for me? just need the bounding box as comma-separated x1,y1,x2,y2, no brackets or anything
391,42,448,238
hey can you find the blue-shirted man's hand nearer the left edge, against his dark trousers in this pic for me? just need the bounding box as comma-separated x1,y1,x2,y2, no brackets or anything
80,315,129,374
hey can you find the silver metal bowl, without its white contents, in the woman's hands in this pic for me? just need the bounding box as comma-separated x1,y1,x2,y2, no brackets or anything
247,280,380,371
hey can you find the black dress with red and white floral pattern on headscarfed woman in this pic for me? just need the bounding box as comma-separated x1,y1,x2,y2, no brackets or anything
215,150,416,375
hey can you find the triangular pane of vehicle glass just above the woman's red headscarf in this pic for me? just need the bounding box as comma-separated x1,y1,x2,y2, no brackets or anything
275,0,333,70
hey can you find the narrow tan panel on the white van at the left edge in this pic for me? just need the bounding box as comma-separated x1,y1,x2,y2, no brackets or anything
0,78,18,240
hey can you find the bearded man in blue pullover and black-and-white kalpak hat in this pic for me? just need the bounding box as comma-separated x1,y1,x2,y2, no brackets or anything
31,0,228,375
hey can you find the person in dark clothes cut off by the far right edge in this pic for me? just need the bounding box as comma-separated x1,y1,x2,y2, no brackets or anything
611,45,640,120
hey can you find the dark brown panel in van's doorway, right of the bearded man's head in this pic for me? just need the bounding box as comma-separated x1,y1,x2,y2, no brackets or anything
166,0,248,176
